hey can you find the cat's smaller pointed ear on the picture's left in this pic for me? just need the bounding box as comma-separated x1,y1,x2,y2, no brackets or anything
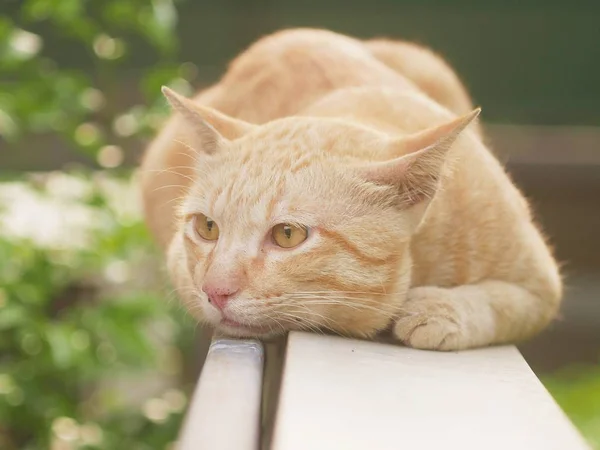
161,86,256,154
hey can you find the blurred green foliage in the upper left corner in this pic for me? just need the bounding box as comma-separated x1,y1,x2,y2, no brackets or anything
0,0,192,162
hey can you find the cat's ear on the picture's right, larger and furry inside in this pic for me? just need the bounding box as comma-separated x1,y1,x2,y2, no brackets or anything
360,108,481,225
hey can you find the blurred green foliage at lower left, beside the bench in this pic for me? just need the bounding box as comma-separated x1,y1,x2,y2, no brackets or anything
0,174,194,450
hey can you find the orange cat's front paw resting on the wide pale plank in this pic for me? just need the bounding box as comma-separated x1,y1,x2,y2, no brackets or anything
393,287,468,351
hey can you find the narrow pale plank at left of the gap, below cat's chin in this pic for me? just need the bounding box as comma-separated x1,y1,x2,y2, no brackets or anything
177,338,264,450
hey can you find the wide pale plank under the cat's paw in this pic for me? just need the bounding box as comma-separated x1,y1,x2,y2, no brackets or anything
272,333,588,450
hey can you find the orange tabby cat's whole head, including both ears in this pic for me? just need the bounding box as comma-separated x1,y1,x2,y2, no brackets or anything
163,88,479,336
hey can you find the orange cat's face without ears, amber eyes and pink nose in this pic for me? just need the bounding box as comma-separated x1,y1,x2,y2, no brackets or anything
173,123,409,335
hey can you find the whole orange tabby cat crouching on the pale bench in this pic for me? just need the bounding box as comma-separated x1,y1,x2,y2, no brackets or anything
141,29,562,351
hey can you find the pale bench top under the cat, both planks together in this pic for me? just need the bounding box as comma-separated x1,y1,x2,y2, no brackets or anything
180,332,589,450
